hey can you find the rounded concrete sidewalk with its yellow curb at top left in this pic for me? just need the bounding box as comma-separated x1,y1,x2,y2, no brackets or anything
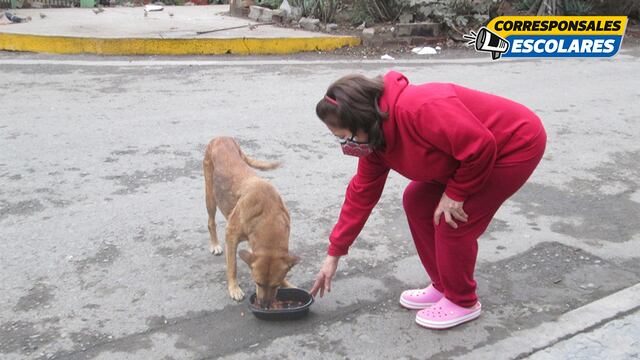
0,5,360,55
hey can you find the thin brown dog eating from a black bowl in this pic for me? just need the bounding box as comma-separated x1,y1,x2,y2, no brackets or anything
203,137,299,307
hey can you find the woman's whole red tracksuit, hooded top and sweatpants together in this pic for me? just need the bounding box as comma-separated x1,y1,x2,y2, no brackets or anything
328,71,546,306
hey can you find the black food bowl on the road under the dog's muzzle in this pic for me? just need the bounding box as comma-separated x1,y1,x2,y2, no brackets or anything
249,288,313,320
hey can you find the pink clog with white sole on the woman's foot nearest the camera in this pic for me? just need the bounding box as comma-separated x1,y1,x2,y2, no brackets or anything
416,297,482,329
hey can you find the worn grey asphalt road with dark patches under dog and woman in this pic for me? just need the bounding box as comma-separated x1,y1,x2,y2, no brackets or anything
0,48,640,359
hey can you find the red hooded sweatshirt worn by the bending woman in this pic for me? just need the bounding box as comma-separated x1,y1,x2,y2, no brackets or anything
328,71,544,256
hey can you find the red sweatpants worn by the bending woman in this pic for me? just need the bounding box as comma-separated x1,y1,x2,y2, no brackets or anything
403,132,546,307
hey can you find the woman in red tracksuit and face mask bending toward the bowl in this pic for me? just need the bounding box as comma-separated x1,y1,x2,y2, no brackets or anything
311,71,547,329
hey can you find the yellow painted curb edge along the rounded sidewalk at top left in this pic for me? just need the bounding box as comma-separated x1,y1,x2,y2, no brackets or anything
0,33,360,55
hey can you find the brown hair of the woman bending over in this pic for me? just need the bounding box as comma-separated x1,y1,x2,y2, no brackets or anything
316,75,388,150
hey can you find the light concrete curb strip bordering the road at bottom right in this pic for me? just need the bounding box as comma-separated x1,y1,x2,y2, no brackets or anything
456,283,640,359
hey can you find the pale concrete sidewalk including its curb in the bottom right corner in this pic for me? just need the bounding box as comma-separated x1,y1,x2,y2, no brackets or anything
460,283,640,360
